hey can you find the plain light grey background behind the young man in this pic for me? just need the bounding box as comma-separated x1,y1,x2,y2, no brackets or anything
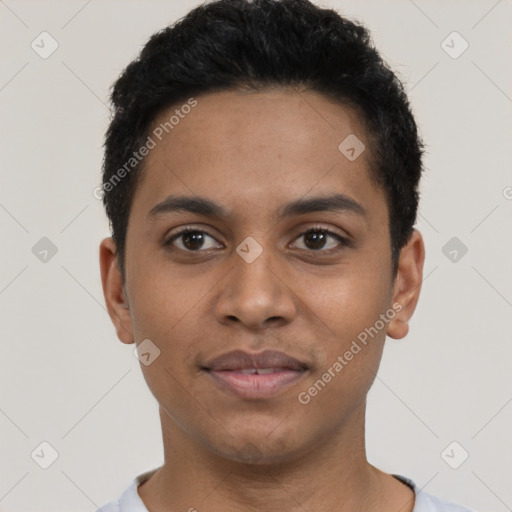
0,0,512,512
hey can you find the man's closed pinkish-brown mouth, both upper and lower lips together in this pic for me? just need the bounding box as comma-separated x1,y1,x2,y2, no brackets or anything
202,350,308,399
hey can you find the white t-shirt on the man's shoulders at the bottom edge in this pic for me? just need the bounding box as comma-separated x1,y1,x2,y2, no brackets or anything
96,468,471,512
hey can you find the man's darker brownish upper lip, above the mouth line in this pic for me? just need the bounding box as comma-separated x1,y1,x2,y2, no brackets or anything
204,350,308,371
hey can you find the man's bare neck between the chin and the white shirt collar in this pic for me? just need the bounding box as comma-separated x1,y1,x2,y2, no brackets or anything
138,404,411,512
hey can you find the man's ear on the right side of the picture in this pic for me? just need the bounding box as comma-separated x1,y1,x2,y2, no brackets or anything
387,229,425,339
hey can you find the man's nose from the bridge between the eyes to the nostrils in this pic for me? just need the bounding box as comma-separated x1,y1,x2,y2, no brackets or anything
215,237,295,328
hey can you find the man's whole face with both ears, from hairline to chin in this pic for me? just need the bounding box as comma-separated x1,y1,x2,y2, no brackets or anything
100,90,423,462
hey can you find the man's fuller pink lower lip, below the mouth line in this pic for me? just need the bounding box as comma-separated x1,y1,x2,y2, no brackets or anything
207,370,306,399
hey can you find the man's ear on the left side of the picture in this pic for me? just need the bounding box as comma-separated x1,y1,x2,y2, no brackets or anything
100,237,134,343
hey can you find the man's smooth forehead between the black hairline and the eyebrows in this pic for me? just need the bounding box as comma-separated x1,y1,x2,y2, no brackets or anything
130,90,380,222
